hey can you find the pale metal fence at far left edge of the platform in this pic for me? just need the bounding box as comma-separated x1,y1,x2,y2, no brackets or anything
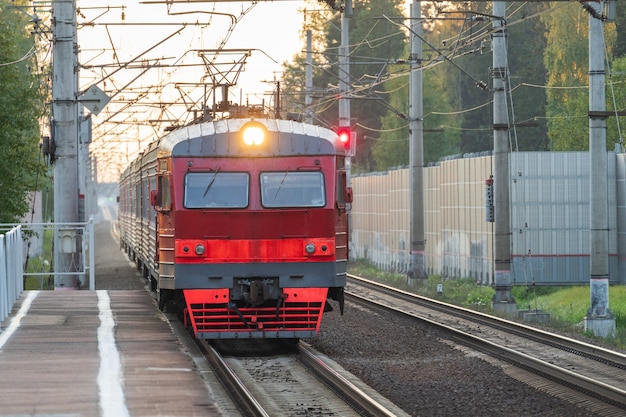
0,226,24,322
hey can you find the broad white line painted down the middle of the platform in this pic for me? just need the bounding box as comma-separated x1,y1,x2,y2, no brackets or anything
96,290,130,417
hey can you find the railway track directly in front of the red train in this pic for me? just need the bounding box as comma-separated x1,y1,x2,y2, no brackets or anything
196,340,406,417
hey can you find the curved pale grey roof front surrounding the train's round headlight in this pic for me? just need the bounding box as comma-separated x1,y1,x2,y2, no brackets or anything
157,118,345,158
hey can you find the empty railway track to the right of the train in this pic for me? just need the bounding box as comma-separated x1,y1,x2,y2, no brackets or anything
346,276,626,416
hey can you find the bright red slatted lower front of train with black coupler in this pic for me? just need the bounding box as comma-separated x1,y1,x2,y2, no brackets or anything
150,272,344,339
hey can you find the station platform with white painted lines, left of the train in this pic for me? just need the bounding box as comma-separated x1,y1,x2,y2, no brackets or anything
0,290,223,417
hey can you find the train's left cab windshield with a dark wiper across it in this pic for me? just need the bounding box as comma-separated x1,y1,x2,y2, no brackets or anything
184,171,250,208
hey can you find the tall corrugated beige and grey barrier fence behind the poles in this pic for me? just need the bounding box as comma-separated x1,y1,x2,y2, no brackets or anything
351,152,626,285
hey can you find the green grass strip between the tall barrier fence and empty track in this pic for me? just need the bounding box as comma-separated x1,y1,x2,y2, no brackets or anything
348,259,626,349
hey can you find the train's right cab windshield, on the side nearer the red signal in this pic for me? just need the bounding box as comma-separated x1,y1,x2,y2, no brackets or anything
260,171,326,208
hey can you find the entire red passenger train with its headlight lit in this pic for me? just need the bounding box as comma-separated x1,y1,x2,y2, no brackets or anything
119,119,351,339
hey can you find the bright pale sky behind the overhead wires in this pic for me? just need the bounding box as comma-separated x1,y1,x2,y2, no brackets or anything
77,0,410,181
